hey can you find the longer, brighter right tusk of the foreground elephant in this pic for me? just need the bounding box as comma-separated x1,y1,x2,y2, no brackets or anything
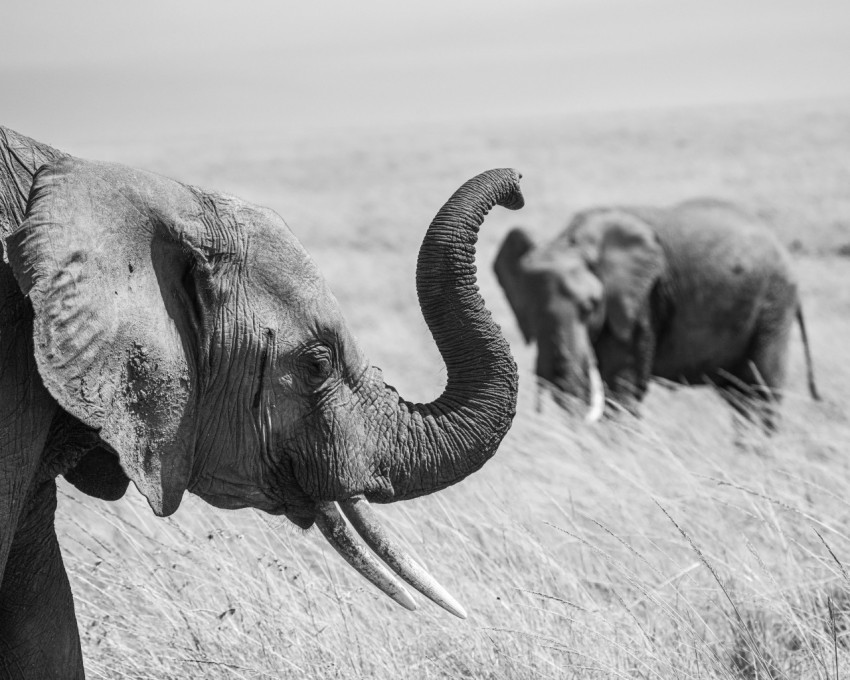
339,496,466,619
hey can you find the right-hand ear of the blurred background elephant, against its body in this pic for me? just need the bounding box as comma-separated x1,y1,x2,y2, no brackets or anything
567,210,666,342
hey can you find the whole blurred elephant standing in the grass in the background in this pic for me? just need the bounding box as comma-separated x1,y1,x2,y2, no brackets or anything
494,198,819,430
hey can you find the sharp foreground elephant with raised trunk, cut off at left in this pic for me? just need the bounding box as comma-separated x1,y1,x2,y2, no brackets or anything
0,128,524,678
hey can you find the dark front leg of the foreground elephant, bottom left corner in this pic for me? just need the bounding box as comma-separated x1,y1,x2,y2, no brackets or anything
0,479,84,680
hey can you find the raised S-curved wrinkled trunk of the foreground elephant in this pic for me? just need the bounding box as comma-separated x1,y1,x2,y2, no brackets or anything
370,169,523,502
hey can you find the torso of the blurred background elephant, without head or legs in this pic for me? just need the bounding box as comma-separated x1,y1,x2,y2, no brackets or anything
654,199,797,382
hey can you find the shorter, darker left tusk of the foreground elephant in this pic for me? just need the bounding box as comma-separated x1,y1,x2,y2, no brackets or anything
316,501,416,611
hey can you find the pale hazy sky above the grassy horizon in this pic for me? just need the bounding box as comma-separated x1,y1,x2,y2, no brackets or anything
0,0,850,147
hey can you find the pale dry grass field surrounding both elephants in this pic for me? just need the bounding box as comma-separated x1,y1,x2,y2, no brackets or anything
58,102,850,680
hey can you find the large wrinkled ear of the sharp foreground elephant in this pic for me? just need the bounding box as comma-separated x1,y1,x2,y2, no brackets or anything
8,158,214,516
